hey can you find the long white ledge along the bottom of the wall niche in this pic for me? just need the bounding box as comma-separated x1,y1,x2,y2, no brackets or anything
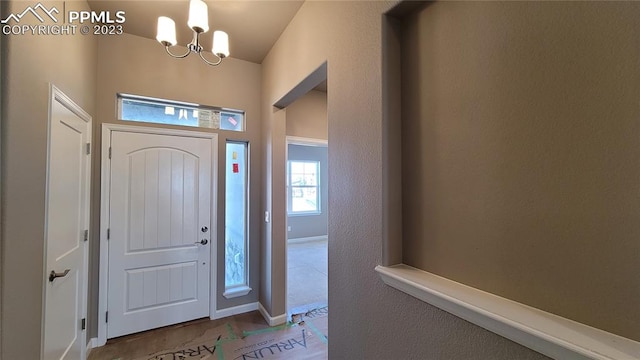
376,264,640,360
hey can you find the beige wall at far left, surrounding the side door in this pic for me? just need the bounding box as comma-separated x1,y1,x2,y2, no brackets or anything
0,1,97,359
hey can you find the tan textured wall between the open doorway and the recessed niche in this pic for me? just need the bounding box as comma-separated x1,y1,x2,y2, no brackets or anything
260,1,544,359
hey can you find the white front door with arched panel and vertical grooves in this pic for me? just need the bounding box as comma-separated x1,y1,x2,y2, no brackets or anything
107,131,214,338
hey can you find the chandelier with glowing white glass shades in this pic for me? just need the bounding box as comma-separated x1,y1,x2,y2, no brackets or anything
156,0,229,66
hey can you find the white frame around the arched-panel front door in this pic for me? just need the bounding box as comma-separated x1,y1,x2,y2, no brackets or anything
97,123,219,346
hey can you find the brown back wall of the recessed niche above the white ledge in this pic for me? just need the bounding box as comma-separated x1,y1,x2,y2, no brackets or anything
402,2,640,340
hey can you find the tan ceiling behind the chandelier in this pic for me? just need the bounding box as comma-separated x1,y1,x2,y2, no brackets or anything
88,0,303,64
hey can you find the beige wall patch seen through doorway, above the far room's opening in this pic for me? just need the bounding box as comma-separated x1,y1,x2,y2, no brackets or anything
286,90,327,140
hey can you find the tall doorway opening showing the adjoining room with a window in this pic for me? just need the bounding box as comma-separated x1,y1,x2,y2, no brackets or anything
286,81,329,314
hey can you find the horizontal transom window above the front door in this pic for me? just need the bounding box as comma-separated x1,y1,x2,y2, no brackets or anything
118,94,245,131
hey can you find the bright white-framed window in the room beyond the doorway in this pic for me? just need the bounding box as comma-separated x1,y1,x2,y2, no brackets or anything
287,160,320,215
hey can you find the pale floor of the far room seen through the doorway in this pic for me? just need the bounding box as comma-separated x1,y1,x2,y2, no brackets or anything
287,240,329,312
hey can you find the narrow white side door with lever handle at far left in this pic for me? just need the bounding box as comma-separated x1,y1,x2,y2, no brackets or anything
43,88,91,360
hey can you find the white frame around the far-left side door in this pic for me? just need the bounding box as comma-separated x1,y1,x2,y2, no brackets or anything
40,83,93,356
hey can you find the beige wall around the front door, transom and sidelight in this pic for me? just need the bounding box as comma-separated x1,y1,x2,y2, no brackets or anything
90,34,262,336
